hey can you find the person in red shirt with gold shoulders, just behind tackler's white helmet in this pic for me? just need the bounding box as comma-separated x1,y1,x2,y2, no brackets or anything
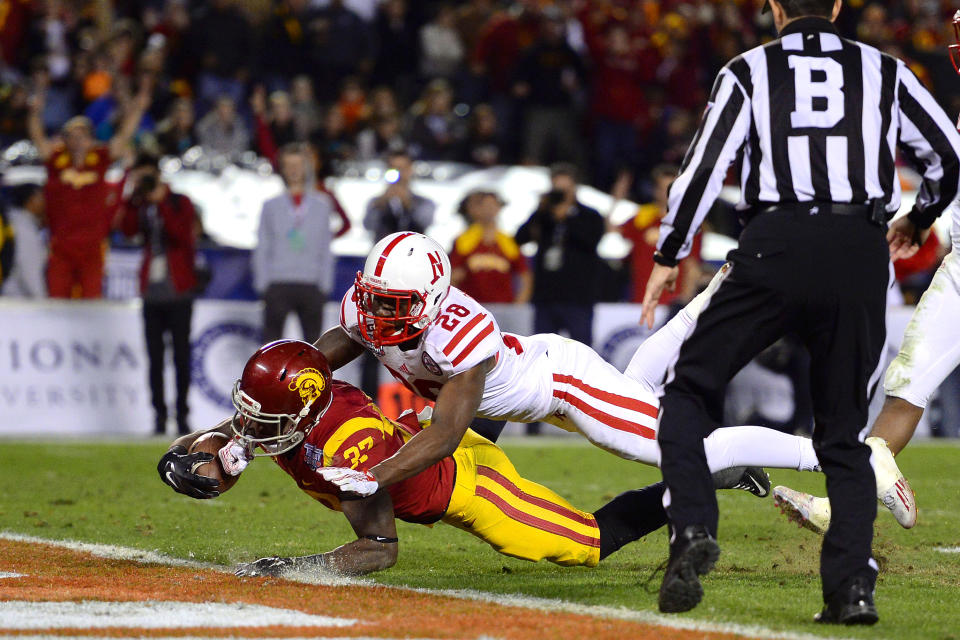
450,191,533,304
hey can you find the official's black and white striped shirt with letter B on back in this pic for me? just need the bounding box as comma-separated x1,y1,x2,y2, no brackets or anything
657,18,960,263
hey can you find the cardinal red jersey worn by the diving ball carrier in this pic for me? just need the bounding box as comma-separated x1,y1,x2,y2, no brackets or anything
274,380,456,524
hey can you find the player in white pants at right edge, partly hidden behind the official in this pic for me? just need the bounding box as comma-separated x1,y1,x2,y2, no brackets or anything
774,11,960,533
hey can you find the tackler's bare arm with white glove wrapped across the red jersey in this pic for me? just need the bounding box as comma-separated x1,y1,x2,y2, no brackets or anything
318,356,496,496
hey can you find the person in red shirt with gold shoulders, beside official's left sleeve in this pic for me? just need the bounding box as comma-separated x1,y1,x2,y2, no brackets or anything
607,165,702,304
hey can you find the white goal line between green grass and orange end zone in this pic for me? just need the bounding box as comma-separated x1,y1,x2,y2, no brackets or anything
0,531,849,640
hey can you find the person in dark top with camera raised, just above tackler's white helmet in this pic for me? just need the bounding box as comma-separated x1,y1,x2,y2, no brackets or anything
363,150,437,242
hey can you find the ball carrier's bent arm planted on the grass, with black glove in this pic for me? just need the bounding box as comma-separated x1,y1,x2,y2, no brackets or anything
235,489,398,576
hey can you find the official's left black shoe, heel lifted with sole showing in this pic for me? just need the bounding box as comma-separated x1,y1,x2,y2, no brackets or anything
659,525,720,613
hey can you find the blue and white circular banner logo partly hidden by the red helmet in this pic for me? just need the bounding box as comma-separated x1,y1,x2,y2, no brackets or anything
190,322,260,409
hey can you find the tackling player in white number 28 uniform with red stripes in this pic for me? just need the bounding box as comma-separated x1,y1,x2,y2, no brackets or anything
316,232,818,496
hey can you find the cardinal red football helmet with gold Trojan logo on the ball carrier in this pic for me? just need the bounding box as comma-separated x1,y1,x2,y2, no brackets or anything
232,340,333,456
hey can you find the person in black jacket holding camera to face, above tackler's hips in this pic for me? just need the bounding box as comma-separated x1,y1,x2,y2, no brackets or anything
516,163,604,345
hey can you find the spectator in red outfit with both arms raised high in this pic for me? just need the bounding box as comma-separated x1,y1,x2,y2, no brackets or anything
27,83,150,298
